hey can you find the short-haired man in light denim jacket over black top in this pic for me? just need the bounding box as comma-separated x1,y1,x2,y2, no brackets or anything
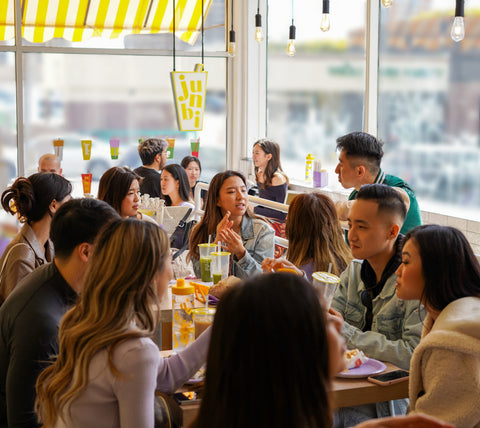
330,184,424,426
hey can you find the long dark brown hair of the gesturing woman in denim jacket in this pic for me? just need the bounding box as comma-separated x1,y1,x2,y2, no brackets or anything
189,170,263,259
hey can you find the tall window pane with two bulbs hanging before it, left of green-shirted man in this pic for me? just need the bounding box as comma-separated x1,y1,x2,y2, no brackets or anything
268,0,366,184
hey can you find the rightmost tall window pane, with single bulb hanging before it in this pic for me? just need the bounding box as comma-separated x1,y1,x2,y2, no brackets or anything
378,0,480,220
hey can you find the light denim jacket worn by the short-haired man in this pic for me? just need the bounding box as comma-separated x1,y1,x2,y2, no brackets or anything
332,260,425,370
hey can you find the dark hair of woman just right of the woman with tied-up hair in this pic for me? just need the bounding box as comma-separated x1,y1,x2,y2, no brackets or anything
98,166,142,215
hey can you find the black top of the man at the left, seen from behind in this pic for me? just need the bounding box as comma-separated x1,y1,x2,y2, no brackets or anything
0,263,77,428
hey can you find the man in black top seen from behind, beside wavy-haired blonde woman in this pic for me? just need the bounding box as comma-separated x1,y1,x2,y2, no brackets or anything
0,199,119,428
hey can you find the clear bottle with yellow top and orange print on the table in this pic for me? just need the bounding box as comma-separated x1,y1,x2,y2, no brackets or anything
172,278,195,352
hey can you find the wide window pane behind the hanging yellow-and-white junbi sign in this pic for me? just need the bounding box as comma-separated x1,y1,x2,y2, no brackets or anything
24,53,226,195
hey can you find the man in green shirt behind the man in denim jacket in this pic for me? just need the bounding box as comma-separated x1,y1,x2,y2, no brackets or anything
335,132,422,234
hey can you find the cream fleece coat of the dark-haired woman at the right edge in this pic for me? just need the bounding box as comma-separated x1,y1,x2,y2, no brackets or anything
409,297,480,428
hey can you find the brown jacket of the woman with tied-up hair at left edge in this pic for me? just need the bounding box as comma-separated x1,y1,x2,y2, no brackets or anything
0,223,54,304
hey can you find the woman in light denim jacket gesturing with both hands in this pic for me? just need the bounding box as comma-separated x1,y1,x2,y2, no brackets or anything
189,170,274,278
